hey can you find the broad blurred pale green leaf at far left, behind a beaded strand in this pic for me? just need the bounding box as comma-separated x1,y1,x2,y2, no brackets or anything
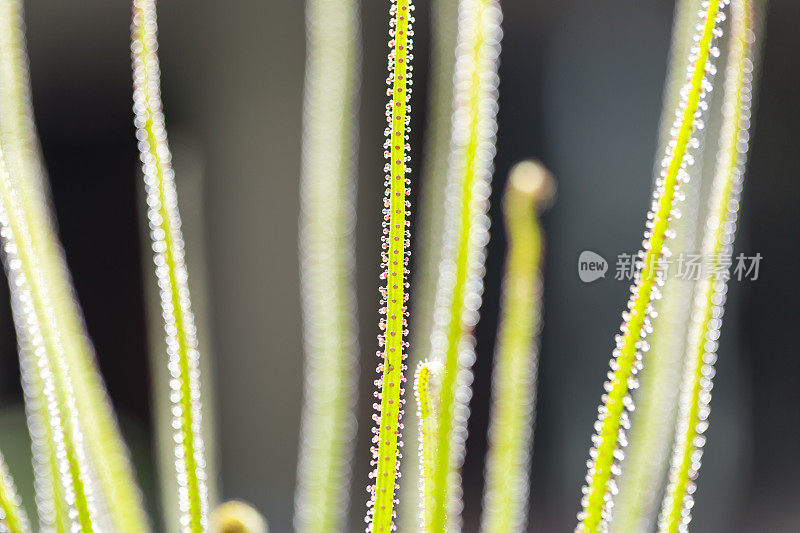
0,0,148,533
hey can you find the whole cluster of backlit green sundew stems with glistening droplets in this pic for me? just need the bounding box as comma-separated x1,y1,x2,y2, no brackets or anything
0,0,763,533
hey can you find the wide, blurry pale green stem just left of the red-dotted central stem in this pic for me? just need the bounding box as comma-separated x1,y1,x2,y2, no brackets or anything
294,0,360,533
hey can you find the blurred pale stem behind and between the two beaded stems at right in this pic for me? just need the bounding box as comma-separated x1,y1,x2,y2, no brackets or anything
610,0,709,533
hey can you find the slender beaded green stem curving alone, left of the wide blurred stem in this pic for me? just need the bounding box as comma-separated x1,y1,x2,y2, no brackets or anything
131,0,208,533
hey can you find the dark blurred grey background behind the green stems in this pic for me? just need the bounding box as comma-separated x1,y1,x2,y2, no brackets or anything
0,0,800,533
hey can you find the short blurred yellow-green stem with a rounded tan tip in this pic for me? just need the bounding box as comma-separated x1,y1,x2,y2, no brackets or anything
481,162,552,533
